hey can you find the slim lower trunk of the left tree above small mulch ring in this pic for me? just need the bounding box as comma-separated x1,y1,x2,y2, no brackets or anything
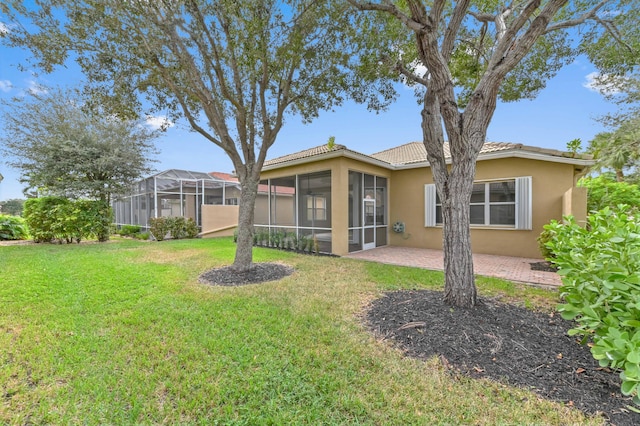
232,174,259,272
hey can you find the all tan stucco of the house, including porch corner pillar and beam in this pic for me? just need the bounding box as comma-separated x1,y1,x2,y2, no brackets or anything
261,157,586,258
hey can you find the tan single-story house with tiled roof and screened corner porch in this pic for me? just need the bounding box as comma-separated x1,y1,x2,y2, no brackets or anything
242,142,593,258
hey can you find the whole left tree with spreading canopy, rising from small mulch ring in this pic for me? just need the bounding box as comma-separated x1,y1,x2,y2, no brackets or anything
0,0,391,271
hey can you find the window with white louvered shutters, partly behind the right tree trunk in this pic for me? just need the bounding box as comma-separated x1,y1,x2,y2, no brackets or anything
425,176,531,229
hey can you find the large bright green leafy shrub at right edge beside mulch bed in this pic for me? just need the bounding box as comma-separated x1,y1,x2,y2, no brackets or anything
545,205,640,404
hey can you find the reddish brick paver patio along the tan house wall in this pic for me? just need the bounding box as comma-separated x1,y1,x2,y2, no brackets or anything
345,246,561,287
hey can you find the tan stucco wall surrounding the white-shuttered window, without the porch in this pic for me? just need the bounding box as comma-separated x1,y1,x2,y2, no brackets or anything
389,158,586,258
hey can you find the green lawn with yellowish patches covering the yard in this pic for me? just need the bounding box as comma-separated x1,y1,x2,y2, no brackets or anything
0,239,599,425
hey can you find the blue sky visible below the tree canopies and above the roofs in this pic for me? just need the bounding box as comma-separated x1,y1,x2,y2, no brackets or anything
0,26,615,200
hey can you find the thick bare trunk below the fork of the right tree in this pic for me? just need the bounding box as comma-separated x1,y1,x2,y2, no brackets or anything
442,168,477,307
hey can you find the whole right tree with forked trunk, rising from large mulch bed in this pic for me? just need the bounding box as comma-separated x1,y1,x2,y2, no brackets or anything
349,0,640,306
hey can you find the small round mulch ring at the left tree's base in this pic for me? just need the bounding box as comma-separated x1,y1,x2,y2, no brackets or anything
199,263,293,287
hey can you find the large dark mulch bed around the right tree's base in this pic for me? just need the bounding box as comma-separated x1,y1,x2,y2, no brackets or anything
366,290,640,425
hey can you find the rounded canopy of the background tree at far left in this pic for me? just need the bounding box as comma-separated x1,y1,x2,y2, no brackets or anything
0,89,158,201
